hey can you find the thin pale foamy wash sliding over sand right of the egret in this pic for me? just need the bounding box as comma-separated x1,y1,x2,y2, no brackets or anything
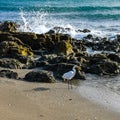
78,76,120,113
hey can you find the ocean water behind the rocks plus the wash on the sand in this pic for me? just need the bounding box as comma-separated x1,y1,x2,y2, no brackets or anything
0,0,120,112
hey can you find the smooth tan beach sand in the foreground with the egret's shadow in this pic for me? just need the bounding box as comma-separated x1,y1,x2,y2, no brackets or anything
0,70,120,120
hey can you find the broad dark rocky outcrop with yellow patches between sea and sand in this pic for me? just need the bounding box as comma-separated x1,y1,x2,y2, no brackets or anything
0,22,120,81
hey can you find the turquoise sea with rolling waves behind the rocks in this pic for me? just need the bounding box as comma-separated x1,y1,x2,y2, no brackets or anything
0,0,120,34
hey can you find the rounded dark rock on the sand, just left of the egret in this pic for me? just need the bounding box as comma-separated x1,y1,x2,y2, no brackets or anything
24,70,55,83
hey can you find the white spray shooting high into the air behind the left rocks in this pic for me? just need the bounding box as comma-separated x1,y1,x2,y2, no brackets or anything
19,10,49,33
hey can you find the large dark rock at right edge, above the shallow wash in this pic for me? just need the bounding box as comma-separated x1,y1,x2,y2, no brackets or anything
85,54,120,75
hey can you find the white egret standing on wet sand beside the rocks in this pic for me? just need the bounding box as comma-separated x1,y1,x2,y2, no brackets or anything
62,65,80,89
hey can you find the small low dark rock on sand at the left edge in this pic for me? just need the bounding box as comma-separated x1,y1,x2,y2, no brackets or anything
0,70,18,79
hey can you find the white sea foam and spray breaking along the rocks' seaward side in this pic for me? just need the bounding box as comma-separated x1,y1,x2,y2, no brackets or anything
19,9,119,41
